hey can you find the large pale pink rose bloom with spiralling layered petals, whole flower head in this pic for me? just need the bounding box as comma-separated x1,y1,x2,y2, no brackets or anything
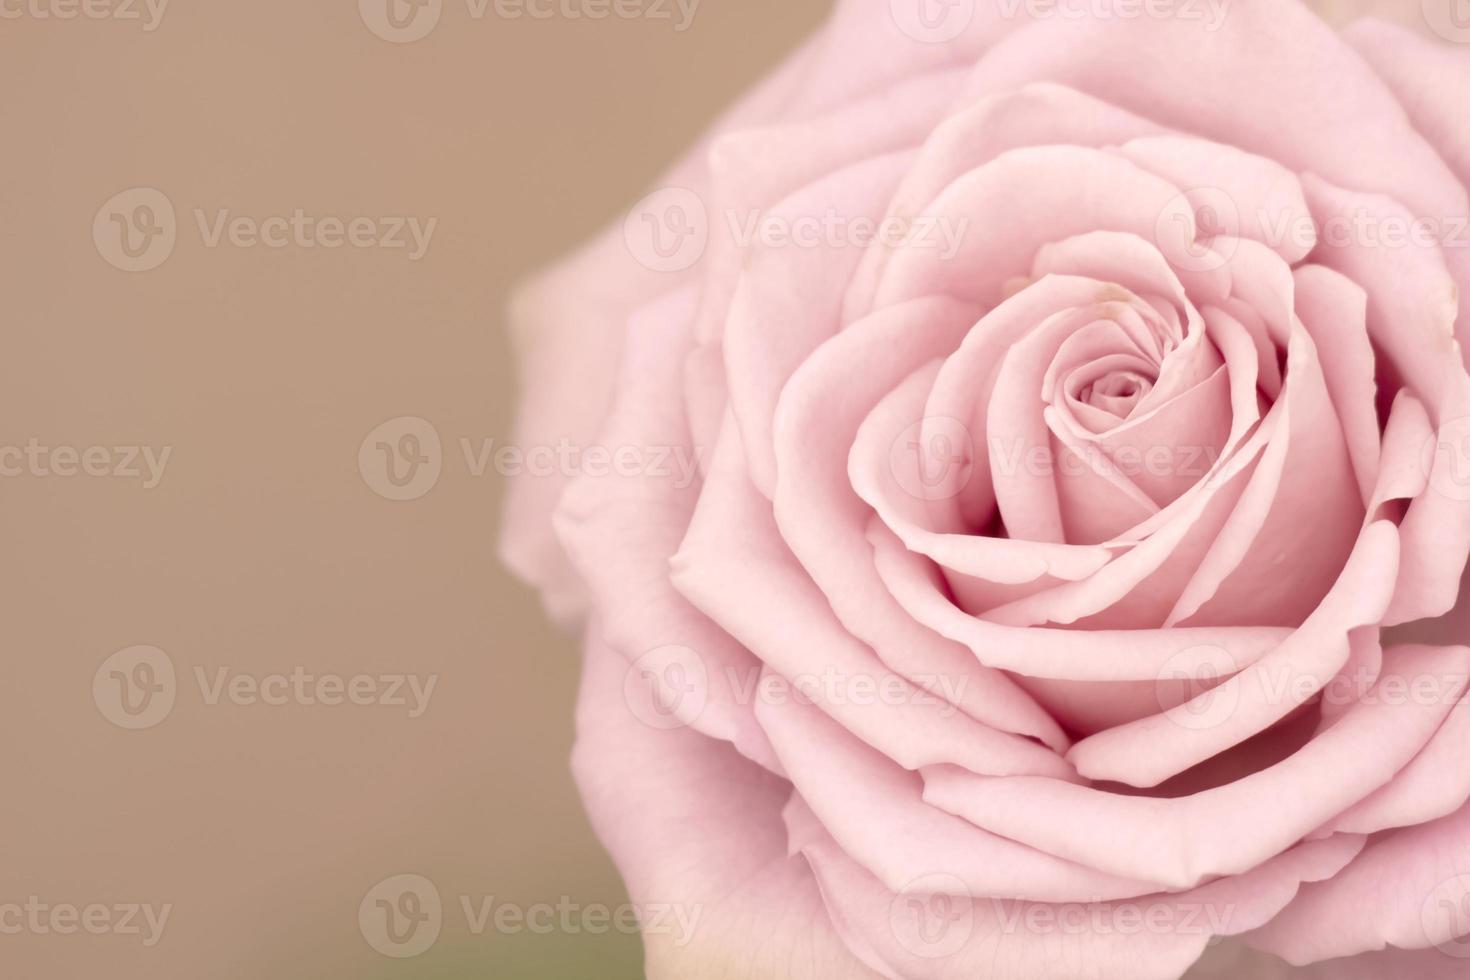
503,0,1470,980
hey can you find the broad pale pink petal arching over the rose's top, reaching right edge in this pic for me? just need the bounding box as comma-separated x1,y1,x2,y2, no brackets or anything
969,0,1466,232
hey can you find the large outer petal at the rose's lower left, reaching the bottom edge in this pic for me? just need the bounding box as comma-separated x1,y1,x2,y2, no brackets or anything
572,638,876,980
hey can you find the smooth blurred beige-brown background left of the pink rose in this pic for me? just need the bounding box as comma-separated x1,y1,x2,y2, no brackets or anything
0,0,1446,980
